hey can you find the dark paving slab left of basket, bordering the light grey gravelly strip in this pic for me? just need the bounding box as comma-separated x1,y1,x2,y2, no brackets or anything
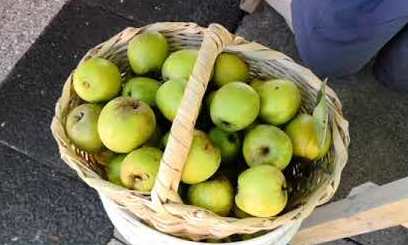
0,1,131,174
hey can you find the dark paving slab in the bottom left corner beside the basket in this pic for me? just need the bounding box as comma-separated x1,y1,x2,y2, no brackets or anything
0,145,113,245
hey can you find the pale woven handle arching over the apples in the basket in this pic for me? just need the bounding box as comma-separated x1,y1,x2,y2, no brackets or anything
151,24,234,210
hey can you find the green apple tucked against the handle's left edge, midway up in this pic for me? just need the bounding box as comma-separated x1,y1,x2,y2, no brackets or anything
156,80,185,121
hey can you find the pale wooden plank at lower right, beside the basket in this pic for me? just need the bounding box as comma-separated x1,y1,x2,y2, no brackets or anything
292,177,408,245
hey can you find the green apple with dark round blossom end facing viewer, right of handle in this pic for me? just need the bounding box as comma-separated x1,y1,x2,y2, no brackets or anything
242,124,293,169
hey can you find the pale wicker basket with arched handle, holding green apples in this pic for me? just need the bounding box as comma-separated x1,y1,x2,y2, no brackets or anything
51,22,349,240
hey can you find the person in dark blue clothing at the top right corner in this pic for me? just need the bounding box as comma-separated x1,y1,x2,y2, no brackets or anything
268,0,408,91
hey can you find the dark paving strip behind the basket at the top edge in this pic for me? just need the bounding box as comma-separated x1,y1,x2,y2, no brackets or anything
88,0,244,31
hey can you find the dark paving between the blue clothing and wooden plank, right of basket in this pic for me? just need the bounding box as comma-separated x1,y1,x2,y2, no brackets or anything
330,66,408,198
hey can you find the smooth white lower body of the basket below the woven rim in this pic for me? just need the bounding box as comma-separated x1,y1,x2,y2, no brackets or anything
99,194,301,245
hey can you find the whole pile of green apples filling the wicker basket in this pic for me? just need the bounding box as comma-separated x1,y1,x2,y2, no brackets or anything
66,32,331,217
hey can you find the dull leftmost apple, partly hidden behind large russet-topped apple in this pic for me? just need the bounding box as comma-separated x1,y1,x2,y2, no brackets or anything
65,104,103,152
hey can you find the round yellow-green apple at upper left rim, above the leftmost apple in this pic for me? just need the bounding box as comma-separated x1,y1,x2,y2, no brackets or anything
73,57,121,102
